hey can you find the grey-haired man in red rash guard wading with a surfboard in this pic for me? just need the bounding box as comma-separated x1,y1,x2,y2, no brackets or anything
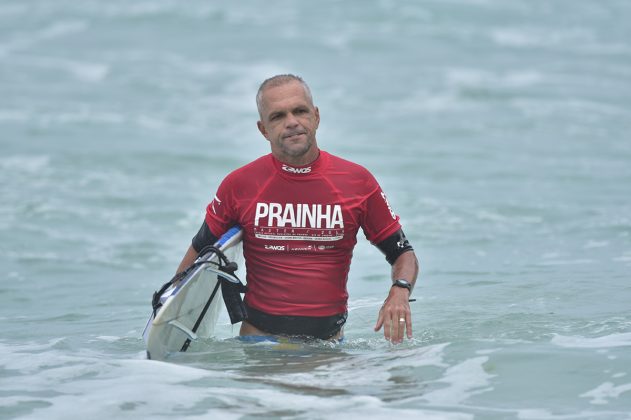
178,75,418,343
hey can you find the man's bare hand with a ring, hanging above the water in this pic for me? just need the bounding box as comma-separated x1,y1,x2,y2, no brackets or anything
375,287,412,344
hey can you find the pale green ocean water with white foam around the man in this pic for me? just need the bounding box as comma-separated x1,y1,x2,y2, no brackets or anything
0,0,631,419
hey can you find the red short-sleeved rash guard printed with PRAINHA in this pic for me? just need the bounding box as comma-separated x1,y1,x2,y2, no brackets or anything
206,151,401,316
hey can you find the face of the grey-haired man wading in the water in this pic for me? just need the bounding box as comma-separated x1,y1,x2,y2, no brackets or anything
258,81,320,166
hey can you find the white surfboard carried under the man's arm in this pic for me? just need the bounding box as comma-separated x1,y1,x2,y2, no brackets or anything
142,226,242,360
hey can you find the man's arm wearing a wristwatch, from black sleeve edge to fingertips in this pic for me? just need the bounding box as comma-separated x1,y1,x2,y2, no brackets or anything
375,230,418,343
